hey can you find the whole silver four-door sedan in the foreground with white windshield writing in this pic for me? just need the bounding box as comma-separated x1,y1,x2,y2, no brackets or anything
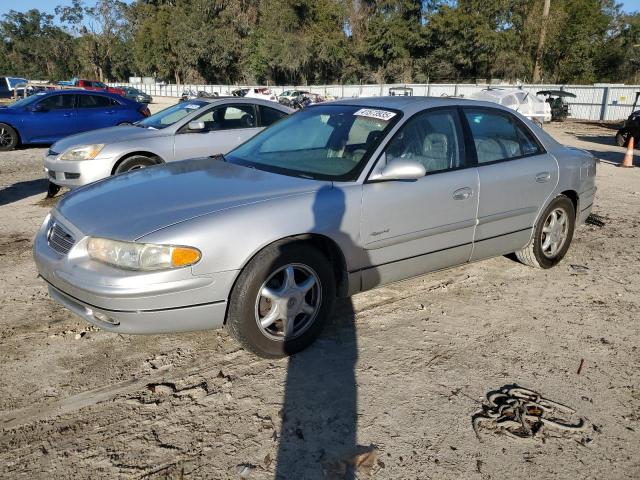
35,97,596,357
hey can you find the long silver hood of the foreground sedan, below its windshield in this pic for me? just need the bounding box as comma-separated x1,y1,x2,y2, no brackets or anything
56,158,330,241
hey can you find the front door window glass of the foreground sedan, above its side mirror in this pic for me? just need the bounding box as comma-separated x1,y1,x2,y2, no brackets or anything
385,110,464,173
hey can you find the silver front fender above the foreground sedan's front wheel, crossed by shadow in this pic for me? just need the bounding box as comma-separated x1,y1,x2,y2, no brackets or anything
138,184,363,275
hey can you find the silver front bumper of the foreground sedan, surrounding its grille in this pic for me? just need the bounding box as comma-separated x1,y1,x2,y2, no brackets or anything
34,213,237,334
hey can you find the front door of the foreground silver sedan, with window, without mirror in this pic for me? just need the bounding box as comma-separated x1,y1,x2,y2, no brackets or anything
362,109,478,289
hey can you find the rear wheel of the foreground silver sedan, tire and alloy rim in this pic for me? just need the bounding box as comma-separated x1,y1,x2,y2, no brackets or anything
516,195,576,268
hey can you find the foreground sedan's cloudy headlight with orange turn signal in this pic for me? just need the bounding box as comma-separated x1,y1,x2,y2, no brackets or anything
87,238,201,270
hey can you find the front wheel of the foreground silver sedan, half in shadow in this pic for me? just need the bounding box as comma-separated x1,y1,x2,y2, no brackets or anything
227,243,336,358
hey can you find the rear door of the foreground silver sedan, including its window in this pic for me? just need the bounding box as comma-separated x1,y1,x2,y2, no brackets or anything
463,108,558,260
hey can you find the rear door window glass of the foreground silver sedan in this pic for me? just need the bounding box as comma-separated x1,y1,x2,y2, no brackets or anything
465,109,542,164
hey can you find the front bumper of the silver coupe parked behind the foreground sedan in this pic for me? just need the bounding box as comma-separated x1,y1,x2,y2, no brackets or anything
44,155,116,189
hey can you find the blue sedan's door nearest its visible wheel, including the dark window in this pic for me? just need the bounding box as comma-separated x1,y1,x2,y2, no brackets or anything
20,93,78,143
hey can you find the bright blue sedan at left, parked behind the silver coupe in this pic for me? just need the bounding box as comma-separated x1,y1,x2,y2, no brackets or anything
0,90,149,151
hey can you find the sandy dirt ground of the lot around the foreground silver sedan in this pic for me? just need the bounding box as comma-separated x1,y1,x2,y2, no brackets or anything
0,113,640,480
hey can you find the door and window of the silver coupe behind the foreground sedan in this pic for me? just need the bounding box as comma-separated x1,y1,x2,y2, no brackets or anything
174,103,262,160
